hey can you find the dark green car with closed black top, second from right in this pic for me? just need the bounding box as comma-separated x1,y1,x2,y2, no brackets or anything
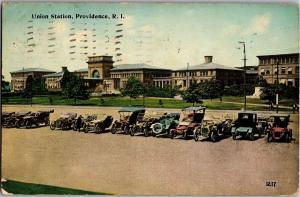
231,111,263,141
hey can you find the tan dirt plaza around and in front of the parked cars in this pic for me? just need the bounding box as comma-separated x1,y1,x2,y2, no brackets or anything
2,106,299,195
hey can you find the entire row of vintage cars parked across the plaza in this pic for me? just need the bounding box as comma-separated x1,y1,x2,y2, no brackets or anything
1,106,292,142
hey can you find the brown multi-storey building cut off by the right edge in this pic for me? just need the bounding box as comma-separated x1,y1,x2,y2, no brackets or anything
257,53,299,87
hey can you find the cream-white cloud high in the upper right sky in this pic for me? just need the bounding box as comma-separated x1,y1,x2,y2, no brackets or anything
248,13,272,33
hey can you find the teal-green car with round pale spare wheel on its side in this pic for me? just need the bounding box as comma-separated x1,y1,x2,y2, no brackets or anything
151,113,180,136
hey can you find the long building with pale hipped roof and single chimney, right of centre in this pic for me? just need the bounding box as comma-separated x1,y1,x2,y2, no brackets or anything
172,56,244,90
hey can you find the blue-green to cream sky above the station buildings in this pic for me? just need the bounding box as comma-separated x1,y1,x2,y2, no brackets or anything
2,2,299,80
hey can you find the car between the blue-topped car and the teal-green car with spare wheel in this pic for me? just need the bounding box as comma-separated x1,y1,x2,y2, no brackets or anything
130,113,162,137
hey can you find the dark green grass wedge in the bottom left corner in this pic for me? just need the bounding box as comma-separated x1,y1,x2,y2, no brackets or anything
1,180,111,195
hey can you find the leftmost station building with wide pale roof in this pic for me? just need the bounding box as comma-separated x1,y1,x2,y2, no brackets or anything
10,68,55,92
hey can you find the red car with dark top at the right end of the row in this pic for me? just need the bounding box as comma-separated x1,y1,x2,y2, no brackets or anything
267,114,293,142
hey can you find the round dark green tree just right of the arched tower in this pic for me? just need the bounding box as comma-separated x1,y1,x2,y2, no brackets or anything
120,77,144,105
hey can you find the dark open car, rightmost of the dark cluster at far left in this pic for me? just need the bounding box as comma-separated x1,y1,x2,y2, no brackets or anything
20,109,54,129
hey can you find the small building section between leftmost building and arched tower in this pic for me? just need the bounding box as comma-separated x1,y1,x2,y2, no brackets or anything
44,66,67,92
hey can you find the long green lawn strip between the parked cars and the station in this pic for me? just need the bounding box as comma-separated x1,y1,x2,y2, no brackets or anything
2,96,291,110
